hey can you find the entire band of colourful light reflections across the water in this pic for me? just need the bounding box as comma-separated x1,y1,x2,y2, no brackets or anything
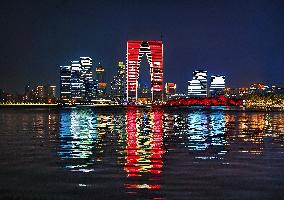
55,107,284,198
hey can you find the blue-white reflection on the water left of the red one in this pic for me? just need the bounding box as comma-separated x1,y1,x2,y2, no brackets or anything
59,109,97,172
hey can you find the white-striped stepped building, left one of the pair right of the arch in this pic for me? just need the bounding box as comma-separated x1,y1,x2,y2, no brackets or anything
188,70,207,97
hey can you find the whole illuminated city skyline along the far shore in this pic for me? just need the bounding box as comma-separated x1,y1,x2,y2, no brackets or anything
0,40,284,110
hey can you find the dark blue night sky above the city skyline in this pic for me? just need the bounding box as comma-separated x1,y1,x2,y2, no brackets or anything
0,0,284,92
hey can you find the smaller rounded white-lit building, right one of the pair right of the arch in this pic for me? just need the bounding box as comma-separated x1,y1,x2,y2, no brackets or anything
210,75,225,97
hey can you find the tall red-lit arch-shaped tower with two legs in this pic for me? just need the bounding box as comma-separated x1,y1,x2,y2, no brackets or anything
126,40,163,102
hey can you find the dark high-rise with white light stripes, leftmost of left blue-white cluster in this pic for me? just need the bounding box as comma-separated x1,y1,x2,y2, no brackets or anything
60,66,71,104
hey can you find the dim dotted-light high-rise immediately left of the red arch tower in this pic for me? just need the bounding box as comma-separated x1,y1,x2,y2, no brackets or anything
110,62,126,103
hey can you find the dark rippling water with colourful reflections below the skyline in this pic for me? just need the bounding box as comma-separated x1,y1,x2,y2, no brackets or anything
0,107,284,199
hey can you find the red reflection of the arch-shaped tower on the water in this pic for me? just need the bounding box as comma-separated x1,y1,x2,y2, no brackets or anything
124,107,164,190
